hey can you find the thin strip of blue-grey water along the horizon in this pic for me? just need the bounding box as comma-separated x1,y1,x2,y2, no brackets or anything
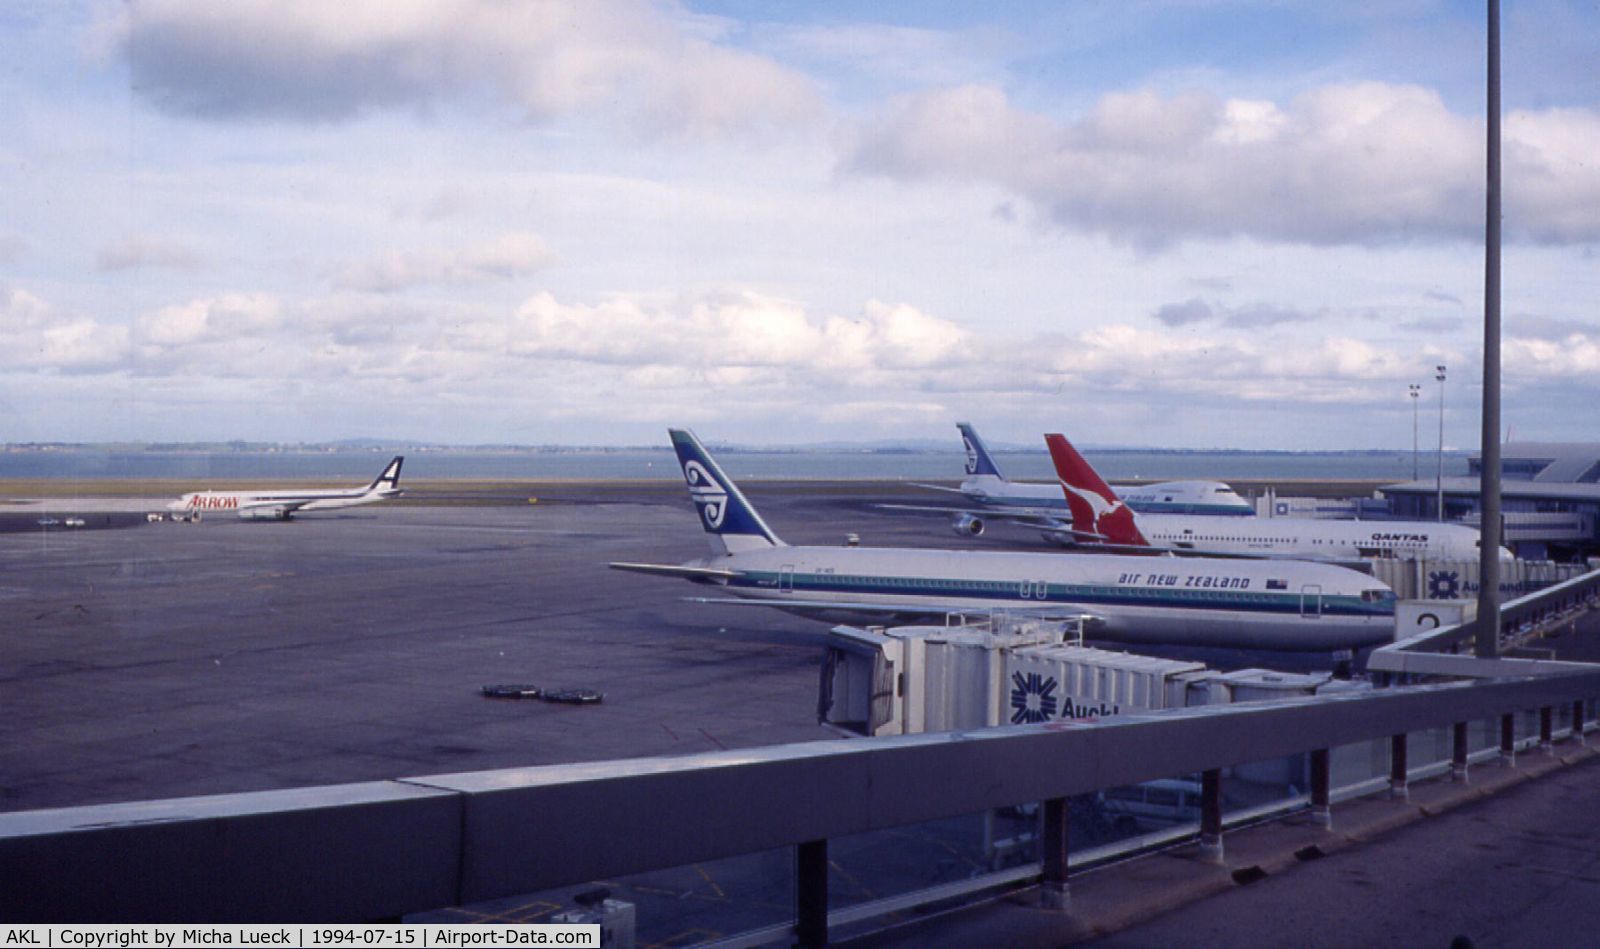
0,446,1467,482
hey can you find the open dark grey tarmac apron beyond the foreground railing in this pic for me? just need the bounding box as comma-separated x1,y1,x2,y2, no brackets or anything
0,485,985,810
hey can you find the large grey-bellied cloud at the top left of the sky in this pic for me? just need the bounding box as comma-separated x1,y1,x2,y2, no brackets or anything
99,0,819,136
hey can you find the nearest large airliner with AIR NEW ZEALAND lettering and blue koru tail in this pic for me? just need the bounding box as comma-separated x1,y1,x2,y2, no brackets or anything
611,429,1395,650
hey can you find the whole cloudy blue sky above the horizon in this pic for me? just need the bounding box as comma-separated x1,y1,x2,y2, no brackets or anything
0,0,1600,450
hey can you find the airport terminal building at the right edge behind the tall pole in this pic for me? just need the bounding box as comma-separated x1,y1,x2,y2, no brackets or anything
1379,442,1600,560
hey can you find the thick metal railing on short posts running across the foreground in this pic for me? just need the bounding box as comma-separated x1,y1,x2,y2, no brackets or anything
0,667,1600,941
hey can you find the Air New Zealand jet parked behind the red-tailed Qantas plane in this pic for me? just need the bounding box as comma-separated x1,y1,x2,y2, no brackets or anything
880,422,1256,539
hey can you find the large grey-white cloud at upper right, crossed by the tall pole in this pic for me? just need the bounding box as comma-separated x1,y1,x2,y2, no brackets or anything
842,82,1600,248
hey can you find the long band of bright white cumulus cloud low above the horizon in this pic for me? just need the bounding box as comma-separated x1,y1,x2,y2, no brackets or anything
18,281,1600,441
